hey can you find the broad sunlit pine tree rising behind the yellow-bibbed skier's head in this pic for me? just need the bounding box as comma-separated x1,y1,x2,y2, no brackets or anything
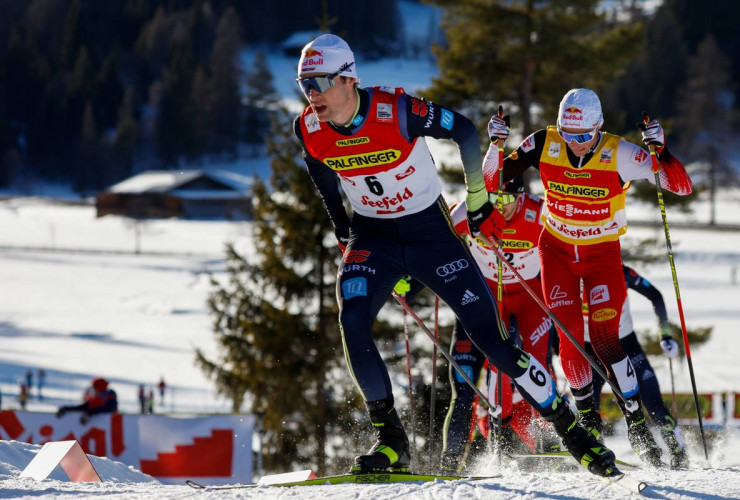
425,0,641,135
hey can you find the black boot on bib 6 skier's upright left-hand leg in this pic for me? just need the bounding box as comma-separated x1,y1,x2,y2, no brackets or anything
350,396,411,474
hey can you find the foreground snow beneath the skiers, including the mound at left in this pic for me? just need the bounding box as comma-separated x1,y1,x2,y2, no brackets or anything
0,436,740,500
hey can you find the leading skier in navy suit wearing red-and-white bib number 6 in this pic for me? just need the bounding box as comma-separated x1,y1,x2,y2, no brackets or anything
294,34,616,475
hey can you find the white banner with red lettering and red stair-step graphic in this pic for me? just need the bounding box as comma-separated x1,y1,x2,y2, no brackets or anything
0,410,255,484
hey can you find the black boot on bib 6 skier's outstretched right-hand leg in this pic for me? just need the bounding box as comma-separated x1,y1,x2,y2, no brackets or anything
544,401,617,477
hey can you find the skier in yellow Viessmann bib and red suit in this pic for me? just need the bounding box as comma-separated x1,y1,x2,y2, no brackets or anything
484,89,692,466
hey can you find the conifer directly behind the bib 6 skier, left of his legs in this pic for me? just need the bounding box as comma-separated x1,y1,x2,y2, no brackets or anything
196,107,359,473
